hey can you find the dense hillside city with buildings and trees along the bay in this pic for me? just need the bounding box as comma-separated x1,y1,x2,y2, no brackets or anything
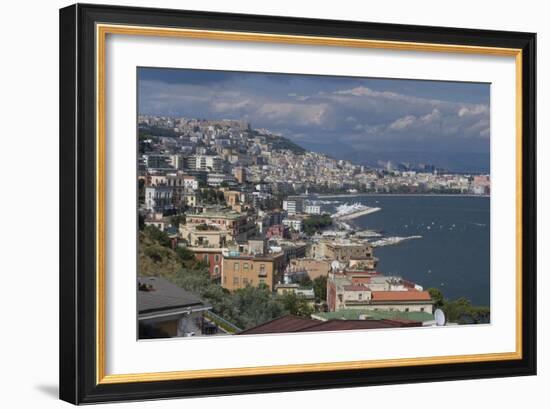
138,115,490,338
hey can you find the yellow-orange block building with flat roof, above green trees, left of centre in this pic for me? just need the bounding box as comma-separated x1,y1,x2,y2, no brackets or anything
221,252,284,291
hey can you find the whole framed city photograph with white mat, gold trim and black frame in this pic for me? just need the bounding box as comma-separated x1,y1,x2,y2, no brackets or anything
60,5,536,404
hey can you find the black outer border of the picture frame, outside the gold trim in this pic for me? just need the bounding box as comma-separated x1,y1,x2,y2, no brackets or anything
59,4,536,404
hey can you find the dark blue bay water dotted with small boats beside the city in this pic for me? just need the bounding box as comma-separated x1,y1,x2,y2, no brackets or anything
322,195,491,306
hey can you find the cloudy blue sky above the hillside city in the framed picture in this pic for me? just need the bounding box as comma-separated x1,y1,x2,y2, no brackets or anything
138,67,490,171
